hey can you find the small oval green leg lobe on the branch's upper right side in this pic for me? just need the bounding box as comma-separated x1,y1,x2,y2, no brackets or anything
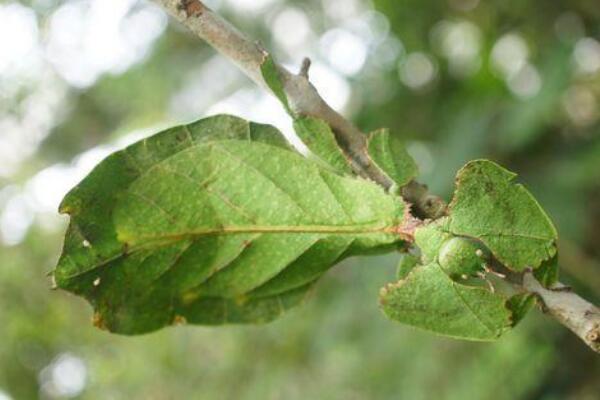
368,129,418,188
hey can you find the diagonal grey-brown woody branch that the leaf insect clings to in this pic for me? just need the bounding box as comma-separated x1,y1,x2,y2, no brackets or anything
155,0,600,352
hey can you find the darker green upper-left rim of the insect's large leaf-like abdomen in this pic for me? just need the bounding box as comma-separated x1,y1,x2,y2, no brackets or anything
55,115,291,286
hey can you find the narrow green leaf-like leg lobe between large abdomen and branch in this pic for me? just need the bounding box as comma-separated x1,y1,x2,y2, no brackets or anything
294,117,353,175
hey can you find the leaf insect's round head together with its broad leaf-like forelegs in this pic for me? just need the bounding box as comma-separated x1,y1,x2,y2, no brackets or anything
381,160,557,340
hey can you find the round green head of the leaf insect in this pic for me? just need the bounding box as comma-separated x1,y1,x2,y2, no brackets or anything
438,237,484,278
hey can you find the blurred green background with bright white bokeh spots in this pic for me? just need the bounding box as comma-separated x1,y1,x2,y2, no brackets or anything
0,0,600,400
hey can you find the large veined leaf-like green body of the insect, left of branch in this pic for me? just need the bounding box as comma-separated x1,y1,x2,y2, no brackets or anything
55,116,404,334
